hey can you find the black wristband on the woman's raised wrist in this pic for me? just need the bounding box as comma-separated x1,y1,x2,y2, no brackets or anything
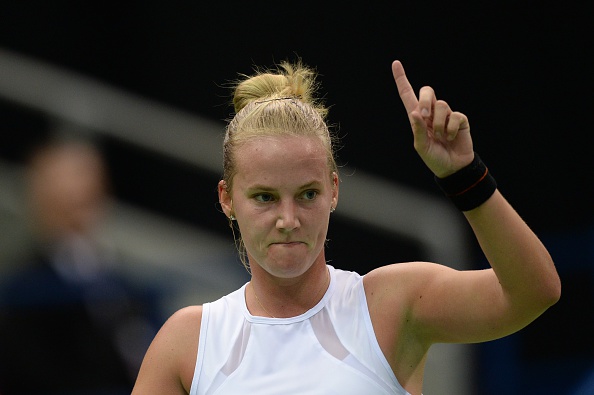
435,152,497,211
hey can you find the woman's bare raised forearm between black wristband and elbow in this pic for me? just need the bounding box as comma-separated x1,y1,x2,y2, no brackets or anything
464,190,561,313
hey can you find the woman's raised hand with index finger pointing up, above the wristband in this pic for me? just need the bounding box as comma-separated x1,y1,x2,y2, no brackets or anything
392,60,474,178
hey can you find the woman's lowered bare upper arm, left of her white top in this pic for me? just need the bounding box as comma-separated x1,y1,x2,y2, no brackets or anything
132,306,202,395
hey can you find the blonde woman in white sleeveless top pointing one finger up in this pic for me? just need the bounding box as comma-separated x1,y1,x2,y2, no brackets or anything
133,61,561,395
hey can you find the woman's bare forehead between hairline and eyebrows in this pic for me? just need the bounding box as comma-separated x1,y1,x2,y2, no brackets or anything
235,136,330,186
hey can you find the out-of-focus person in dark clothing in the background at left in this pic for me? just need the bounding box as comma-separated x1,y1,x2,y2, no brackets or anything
0,141,158,395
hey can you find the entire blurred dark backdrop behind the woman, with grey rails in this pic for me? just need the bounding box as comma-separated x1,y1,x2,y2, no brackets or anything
0,0,594,395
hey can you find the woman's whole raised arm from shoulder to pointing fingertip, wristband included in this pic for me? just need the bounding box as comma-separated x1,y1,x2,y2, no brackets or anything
366,61,561,345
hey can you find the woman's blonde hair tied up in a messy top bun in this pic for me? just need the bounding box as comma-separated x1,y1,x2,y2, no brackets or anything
223,61,338,271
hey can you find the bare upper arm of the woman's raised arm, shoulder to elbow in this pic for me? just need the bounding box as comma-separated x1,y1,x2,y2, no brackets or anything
365,262,531,346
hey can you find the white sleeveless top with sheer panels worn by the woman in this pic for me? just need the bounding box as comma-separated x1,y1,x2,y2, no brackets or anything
190,266,410,395
